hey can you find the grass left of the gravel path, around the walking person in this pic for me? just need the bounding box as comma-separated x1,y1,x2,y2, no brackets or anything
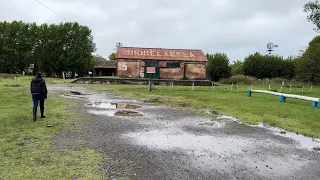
0,77,103,180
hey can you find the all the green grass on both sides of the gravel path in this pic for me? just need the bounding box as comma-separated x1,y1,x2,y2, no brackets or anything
0,77,320,180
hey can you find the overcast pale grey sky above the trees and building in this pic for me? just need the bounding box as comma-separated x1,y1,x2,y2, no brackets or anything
0,0,316,61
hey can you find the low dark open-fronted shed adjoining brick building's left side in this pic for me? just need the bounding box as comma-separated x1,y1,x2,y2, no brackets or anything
93,60,117,76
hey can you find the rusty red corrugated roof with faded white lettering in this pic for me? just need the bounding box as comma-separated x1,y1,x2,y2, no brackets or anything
116,47,208,61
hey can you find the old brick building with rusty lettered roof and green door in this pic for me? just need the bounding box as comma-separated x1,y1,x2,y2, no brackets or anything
116,47,208,80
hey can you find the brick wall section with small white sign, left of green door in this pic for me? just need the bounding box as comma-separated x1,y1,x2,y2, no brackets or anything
117,60,141,78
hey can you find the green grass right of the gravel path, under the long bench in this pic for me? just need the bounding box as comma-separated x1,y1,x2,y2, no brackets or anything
94,85,320,138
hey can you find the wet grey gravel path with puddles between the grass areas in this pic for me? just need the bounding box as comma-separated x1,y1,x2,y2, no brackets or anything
49,85,320,180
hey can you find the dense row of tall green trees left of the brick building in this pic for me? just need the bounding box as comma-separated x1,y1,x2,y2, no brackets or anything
0,21,96,76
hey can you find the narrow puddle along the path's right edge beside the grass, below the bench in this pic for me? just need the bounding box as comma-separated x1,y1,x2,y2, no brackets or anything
251,123,320,150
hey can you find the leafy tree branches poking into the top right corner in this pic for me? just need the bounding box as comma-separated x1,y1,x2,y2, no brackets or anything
304,0,320,32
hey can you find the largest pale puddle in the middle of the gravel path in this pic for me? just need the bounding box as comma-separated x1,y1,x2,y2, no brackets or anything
125,130,253,156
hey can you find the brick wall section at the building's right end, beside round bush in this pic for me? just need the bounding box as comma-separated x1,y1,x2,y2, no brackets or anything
185,63,206,80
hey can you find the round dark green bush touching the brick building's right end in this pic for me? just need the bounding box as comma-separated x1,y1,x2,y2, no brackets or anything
206,53,231,81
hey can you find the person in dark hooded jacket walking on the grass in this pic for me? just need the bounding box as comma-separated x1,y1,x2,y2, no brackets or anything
30,73,48,121
